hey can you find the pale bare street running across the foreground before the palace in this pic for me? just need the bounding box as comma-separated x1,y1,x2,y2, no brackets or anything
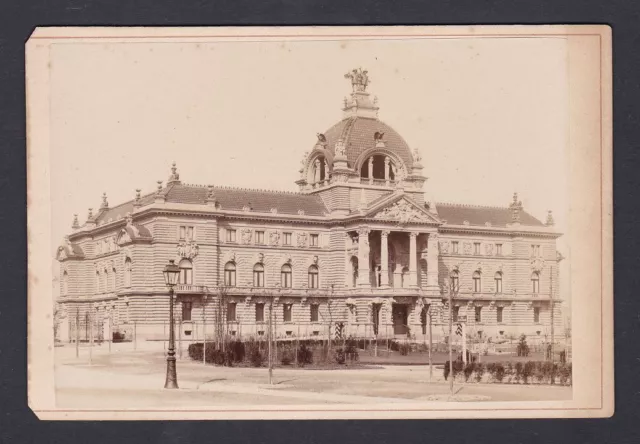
55,343,571,408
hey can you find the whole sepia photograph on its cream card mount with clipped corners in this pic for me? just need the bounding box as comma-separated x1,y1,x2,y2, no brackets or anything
26,26,613,419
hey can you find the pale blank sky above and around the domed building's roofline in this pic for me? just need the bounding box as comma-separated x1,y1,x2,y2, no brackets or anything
50,38,569,308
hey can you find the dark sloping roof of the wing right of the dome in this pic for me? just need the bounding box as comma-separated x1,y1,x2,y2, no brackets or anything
436,203,544,227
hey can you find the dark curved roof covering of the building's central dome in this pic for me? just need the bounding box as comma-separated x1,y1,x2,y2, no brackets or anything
316,116,413,171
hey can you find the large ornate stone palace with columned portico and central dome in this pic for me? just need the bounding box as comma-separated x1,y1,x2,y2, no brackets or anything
57,70,562,341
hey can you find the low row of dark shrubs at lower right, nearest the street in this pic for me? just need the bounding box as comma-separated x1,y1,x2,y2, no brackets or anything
444,360,572,385
